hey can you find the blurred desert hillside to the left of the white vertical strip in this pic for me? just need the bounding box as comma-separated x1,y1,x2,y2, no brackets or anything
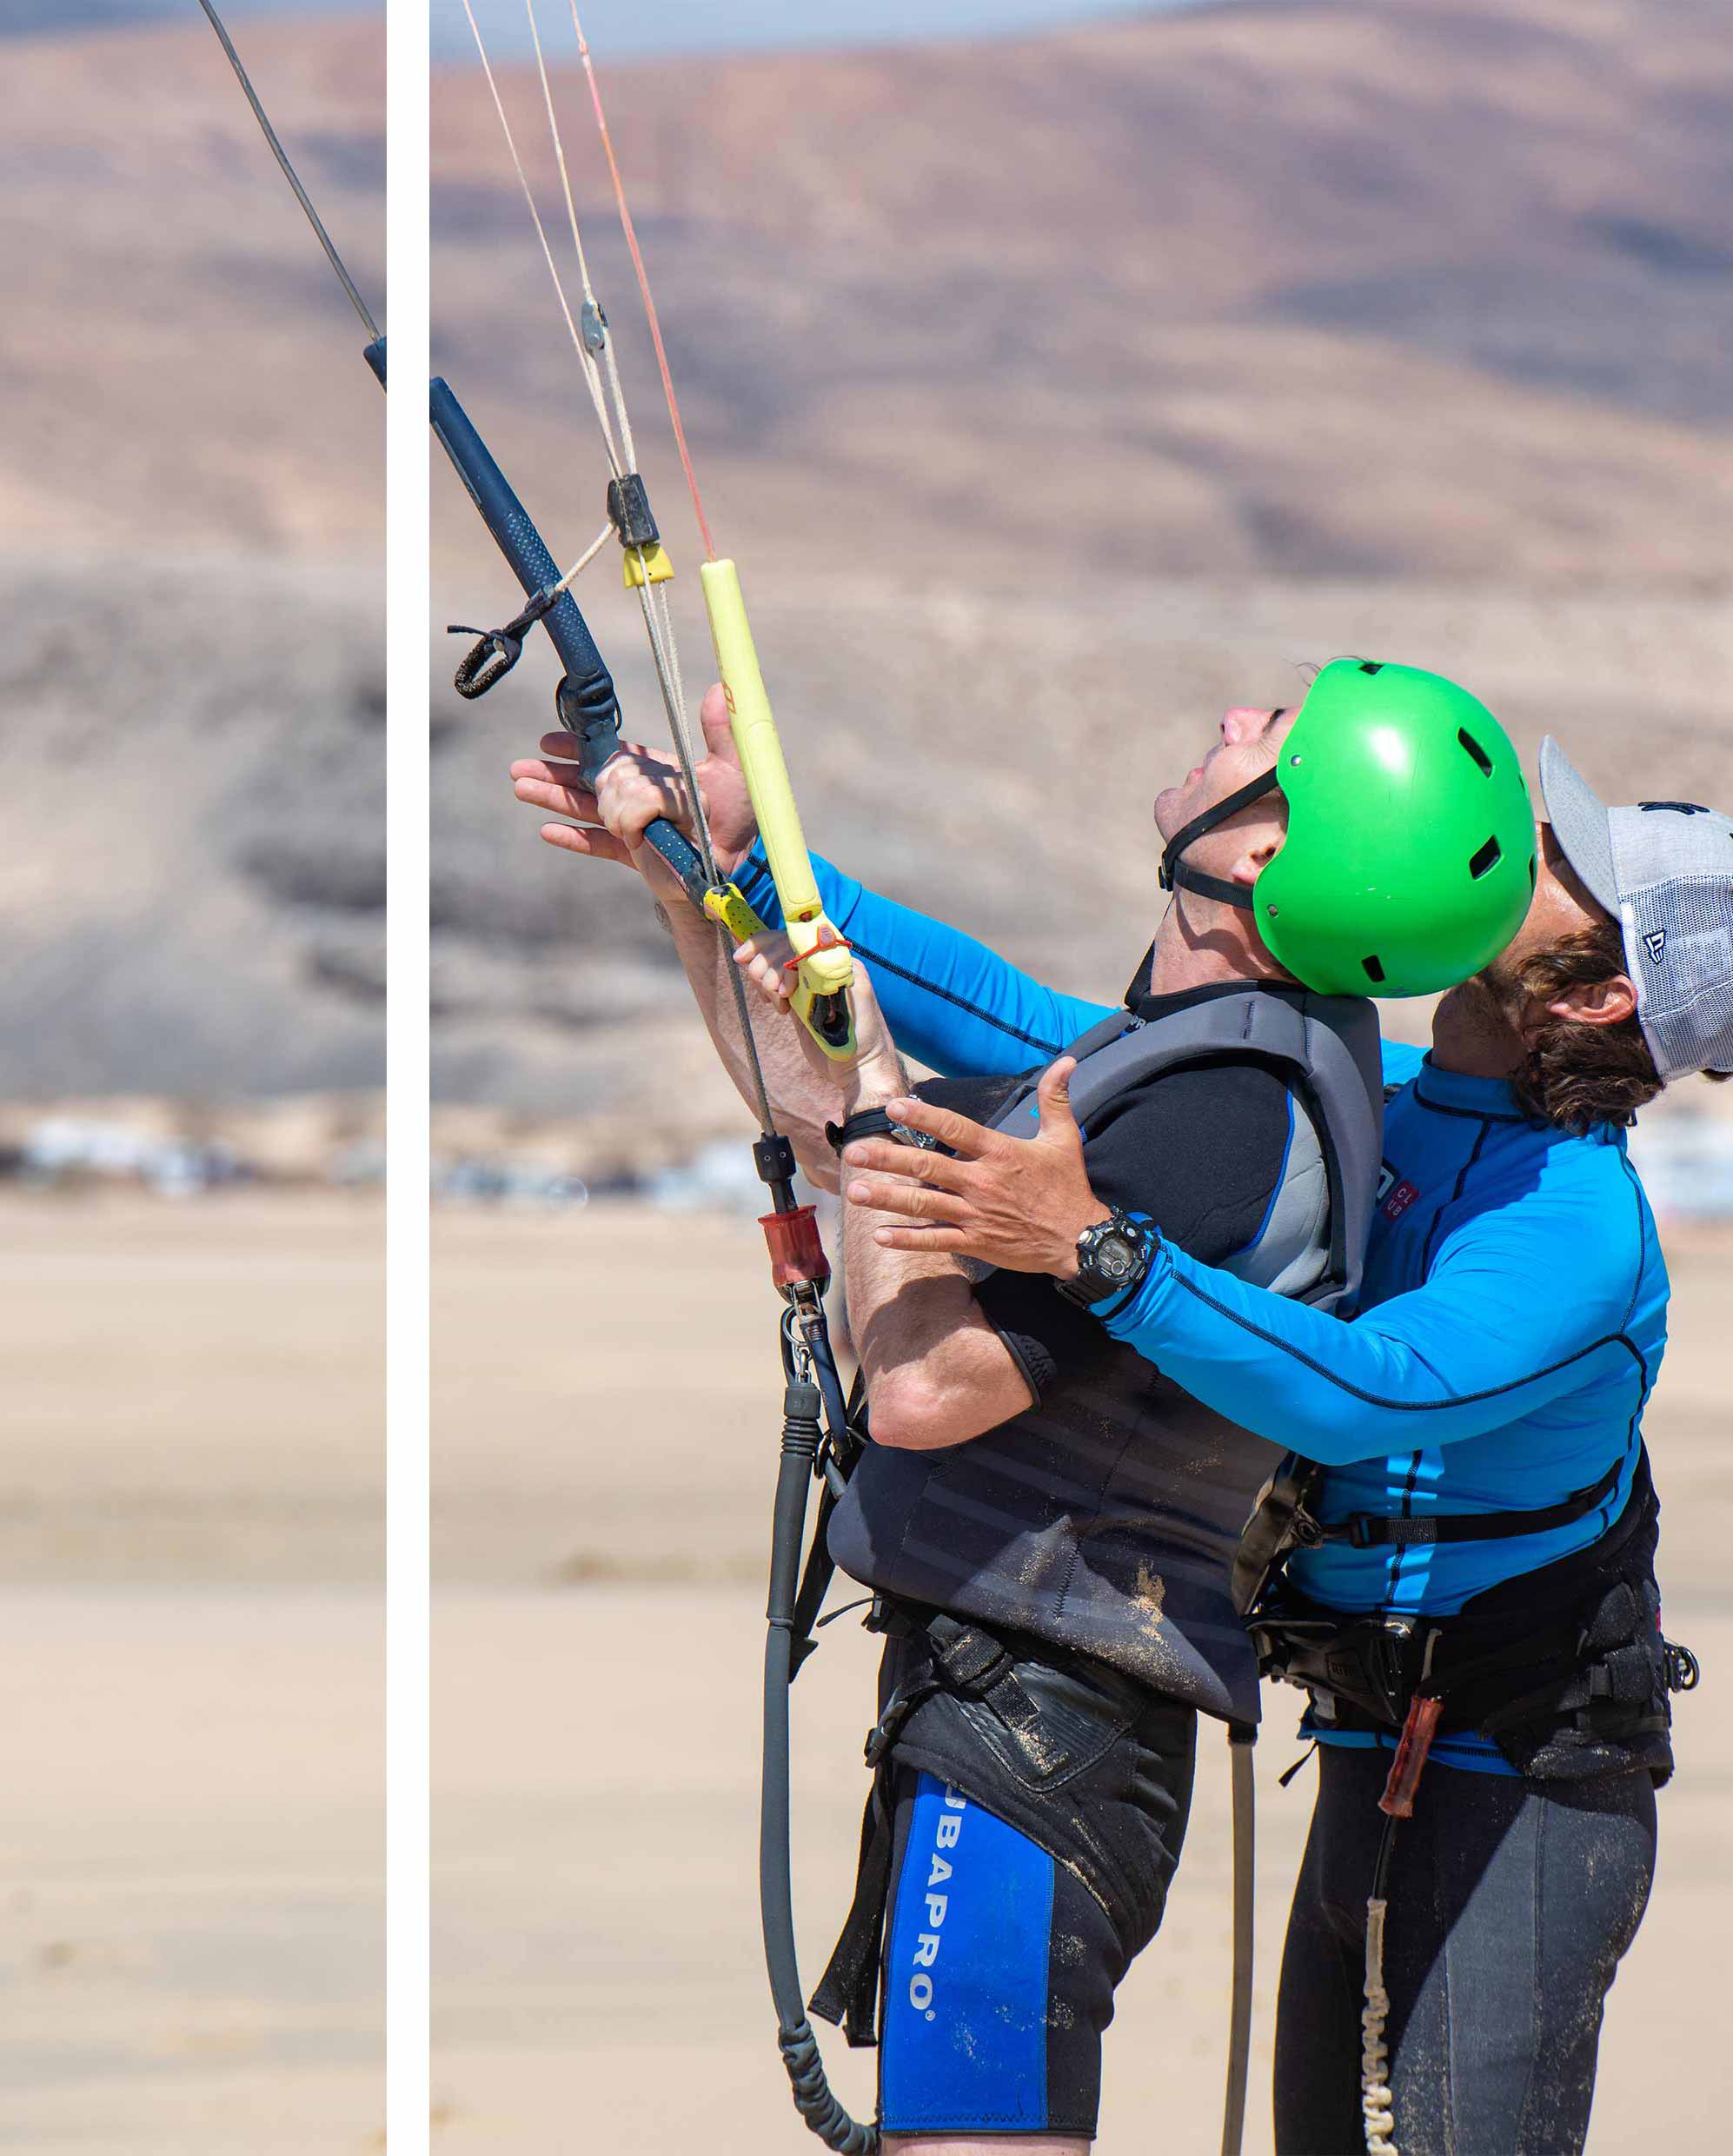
0,9,383,1101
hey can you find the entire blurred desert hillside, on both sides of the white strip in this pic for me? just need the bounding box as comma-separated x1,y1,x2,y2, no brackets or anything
0,0,1733,1142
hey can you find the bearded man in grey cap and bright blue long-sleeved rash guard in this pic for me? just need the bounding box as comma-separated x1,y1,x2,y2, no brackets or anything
827,742,1733,2156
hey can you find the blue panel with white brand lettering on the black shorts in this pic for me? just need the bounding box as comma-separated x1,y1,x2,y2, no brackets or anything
880,1774,1054,2133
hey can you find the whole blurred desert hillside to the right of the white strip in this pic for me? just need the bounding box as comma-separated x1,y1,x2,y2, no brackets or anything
422,0,1733,1151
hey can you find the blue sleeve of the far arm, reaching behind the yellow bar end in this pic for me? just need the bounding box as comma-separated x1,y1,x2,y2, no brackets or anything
735,845,1114,1078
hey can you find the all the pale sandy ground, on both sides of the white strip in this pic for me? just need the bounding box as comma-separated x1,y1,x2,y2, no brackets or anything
0,1199,1733,2156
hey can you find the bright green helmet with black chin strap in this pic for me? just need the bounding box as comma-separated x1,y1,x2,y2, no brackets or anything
1162,660,1535,996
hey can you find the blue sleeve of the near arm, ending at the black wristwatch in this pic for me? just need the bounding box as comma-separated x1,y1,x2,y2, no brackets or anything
1095,1190,1643,1466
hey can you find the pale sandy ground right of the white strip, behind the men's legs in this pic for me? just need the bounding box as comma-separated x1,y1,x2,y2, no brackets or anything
435,1208,1733,2156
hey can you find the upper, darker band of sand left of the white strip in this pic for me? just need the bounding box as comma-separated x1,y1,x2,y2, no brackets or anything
0,1194,383,1585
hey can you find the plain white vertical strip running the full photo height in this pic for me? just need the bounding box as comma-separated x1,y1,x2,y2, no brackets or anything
386,0,431,2156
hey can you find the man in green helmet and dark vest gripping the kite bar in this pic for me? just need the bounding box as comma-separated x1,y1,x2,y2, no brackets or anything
515,664,1532,2156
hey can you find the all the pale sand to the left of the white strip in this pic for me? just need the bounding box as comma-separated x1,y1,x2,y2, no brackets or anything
0,1196,383,2156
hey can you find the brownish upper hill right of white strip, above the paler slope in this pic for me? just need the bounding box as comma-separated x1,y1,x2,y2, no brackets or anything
434,0,1733,584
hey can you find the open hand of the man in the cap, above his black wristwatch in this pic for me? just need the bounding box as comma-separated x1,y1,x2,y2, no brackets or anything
843,1056,1110,1281
